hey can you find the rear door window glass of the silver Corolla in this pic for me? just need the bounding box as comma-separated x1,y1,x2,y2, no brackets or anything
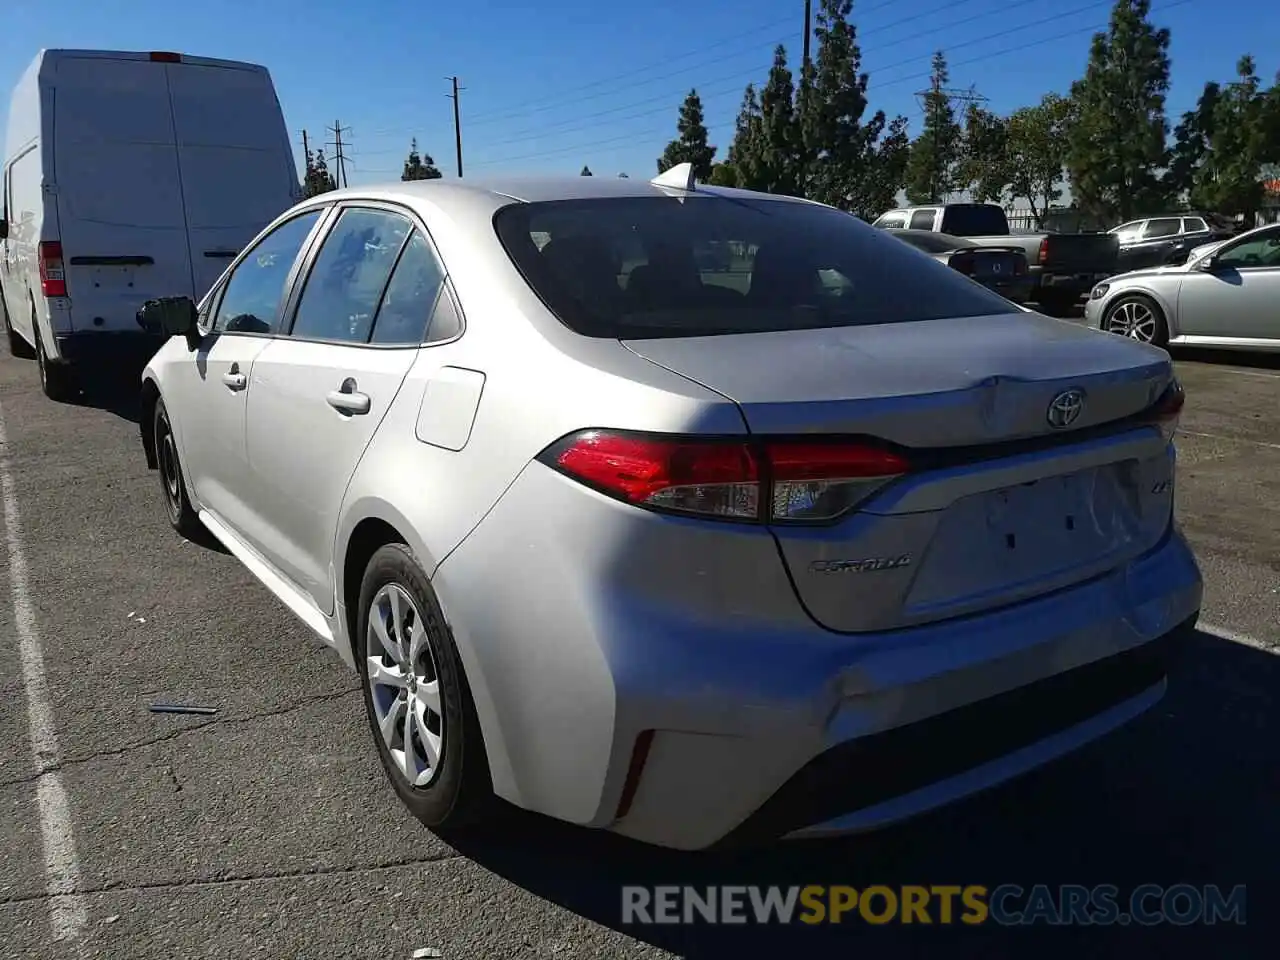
289,207,412,343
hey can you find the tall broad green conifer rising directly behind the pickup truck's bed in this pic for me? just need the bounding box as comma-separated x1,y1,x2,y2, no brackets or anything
1068,0,1169,220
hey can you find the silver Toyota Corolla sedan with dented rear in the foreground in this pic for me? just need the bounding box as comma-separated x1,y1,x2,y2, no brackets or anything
142,166,1202,849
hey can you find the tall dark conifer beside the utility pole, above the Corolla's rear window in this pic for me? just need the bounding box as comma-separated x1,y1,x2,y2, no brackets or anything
800,0,906,218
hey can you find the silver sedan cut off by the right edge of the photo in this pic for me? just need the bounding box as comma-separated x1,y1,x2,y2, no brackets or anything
1084,224,1280,351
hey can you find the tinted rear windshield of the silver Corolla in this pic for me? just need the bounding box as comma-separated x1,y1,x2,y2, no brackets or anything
494,195,1019,339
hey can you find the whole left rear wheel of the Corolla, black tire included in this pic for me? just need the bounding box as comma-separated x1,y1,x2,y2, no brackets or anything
353,544,495,829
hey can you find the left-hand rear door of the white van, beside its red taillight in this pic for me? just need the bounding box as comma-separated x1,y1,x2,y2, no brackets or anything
49,56,192,333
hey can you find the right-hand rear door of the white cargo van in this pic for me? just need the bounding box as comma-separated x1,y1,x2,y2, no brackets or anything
166,61,298,300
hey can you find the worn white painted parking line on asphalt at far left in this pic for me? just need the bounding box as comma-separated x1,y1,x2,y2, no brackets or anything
0,410,88,941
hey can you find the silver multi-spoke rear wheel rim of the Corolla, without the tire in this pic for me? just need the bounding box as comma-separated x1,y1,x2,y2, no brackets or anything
365,584,445,787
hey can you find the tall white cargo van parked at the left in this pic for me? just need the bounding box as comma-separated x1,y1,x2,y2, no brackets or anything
0,50,301,399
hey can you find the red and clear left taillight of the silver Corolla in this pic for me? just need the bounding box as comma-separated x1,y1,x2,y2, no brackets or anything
539,430,910,524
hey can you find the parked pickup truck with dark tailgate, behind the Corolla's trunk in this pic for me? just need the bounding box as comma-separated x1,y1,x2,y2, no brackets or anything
872,204,1120,312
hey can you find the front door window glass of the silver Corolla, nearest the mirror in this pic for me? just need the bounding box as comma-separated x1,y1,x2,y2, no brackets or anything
212,210,321,333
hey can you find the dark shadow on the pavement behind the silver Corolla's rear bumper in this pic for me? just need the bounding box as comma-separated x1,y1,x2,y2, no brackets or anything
447,632,1280,960
